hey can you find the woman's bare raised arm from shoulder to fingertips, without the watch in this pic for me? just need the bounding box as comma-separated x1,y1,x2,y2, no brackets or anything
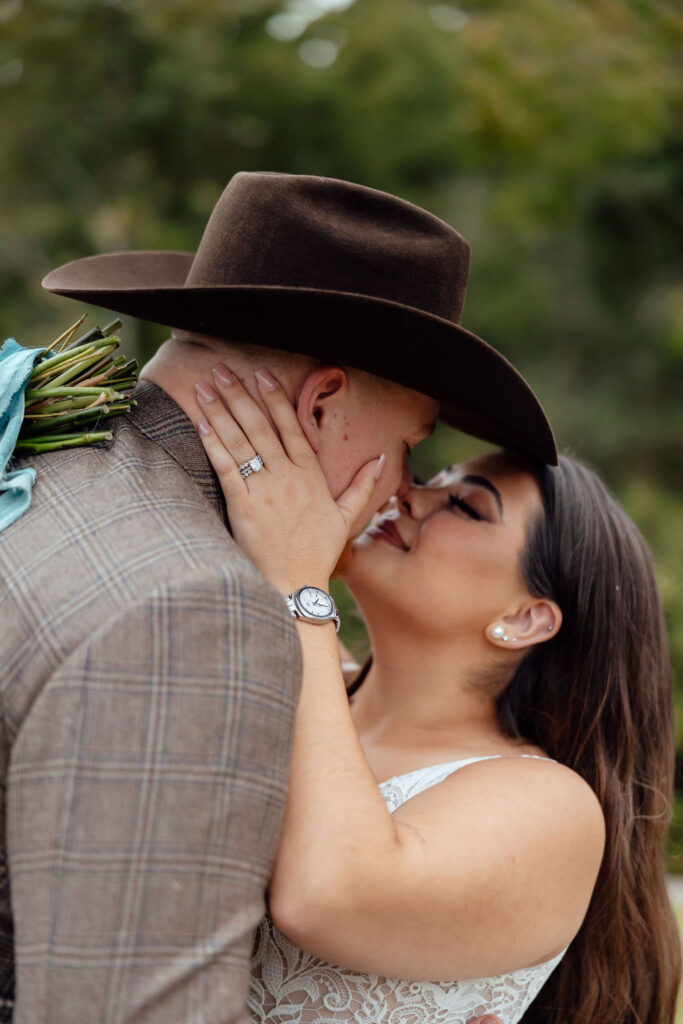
193,372,603,981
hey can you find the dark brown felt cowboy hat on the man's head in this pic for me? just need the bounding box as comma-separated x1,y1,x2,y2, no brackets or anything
43,171,557,465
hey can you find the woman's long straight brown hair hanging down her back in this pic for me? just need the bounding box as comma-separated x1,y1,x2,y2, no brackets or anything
497,457,681,1024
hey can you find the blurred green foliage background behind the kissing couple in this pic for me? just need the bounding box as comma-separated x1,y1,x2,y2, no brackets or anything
0,0,683,872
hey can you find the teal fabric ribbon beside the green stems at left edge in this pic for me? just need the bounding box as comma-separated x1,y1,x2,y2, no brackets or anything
0,338,44,532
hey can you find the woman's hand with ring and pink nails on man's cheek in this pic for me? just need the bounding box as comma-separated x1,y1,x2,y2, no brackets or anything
197,367,384,593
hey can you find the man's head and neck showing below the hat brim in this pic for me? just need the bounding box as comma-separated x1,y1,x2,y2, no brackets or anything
140,330,438,532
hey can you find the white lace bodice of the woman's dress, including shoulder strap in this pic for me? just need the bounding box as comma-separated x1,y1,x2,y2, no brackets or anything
249,754,566,1024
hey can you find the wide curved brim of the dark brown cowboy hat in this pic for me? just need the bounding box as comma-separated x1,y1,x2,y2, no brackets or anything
42,251,557,466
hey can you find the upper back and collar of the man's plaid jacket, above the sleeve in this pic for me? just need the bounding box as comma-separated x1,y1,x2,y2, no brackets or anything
0,382,295,731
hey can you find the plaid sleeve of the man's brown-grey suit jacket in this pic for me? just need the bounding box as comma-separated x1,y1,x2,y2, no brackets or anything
7,566,301,1024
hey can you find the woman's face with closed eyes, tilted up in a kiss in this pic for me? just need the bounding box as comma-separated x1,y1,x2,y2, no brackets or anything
344,453,542,635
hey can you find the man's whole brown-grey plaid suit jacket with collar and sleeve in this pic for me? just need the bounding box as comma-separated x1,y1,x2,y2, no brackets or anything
0,381,301,1024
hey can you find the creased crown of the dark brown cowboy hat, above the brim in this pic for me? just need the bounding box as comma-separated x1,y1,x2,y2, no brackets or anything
185,171,469,324
